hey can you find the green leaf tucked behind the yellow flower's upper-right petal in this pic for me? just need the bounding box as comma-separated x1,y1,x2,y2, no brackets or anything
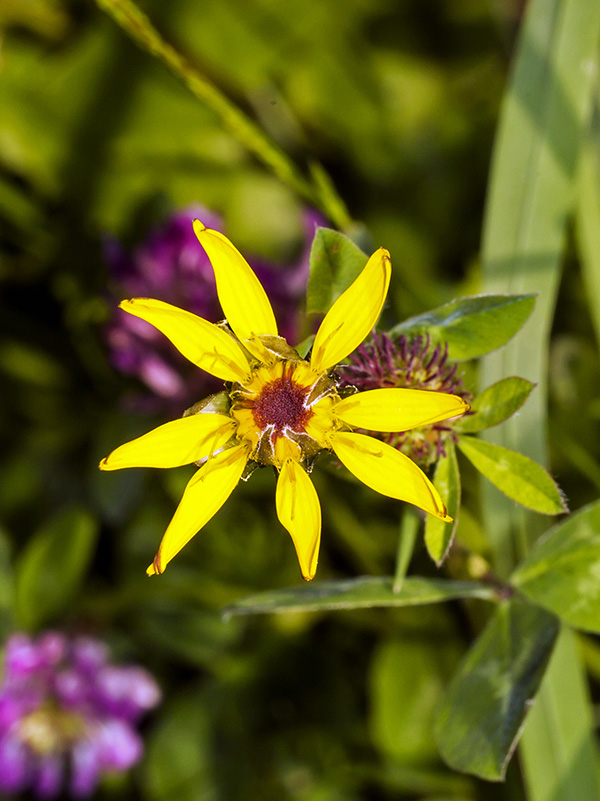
306,228,367,314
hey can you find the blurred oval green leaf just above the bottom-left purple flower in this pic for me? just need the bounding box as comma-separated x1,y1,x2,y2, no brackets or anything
16,507,98,629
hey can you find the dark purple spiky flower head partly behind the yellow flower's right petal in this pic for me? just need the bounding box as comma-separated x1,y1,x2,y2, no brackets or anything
338,333,472,468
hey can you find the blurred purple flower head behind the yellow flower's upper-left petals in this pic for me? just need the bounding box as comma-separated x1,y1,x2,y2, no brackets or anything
104,206,324,413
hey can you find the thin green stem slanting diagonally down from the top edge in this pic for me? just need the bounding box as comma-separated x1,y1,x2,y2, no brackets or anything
96,0,352,229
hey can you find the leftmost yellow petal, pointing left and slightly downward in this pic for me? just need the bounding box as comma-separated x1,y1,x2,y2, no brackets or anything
100,413,235,470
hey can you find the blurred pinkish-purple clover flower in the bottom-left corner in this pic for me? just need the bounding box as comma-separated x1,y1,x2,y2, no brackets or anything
0,632,161,801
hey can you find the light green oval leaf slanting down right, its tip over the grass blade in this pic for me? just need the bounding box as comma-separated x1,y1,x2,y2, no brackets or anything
458,437,568,515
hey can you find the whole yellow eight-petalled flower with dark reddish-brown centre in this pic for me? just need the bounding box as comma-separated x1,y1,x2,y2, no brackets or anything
100,220,469,581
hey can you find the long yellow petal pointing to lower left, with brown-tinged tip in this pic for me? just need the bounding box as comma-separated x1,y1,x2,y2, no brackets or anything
146,445,248,576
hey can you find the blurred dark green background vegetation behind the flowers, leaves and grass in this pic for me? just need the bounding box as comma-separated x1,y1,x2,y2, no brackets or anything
0,0,600,801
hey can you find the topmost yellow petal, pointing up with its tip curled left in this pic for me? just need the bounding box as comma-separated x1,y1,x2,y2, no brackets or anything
194,220,277,348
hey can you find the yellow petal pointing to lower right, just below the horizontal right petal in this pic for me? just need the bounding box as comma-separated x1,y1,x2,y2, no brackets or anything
330,432,452,522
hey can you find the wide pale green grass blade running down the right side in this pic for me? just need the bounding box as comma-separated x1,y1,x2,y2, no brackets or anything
482,0,600,801
